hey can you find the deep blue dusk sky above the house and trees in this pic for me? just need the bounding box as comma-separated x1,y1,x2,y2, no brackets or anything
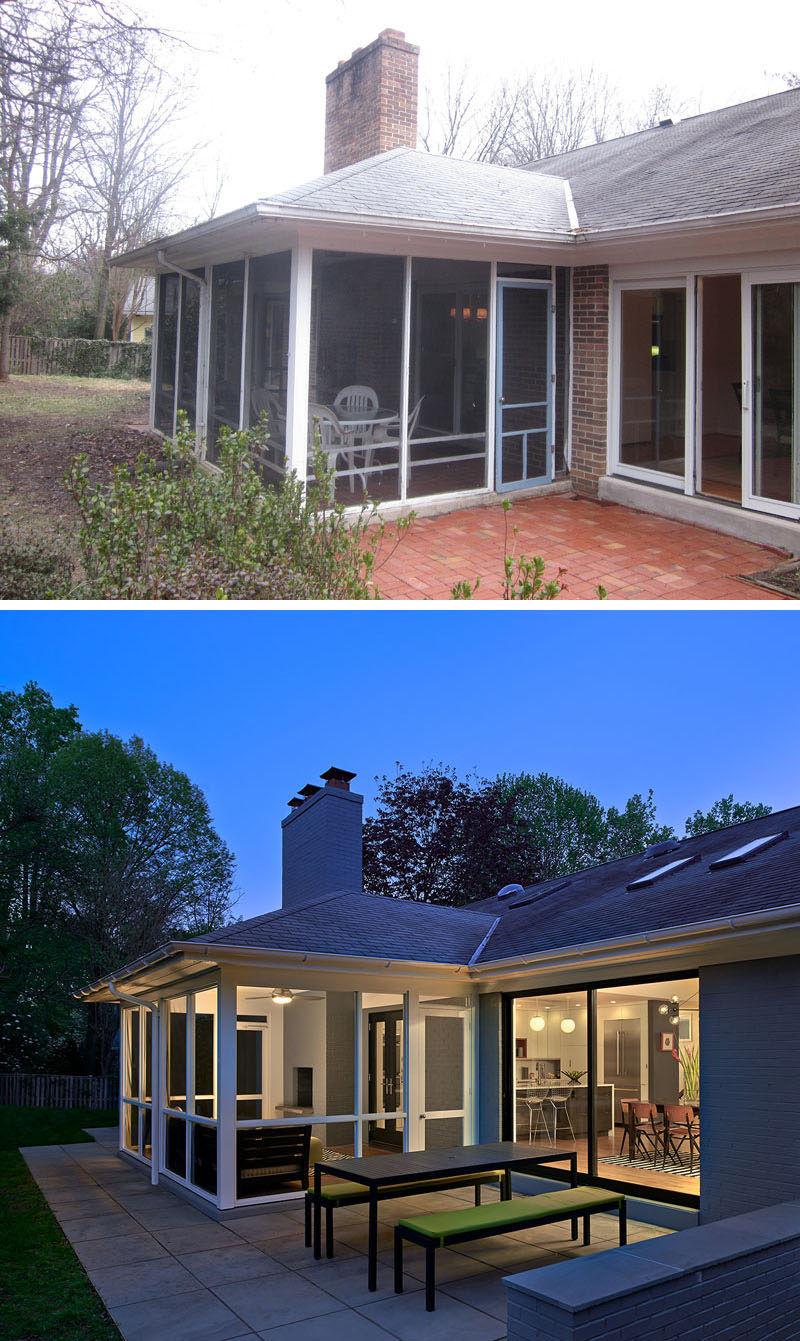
0,606,800,916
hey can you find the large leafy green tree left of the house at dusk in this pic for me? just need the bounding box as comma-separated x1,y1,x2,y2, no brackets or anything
0,684,233,1073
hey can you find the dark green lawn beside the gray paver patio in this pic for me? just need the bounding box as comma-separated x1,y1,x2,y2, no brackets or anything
0,1106,119,1341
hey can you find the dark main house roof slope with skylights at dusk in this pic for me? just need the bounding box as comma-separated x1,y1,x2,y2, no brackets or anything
478,807,800,964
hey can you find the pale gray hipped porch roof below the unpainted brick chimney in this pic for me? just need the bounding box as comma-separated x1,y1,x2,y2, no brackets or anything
263,149,570,237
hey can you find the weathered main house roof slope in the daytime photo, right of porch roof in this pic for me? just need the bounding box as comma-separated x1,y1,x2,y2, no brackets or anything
529,89,800,231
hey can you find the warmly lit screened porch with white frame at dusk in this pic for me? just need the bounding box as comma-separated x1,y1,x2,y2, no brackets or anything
121,974,474,1208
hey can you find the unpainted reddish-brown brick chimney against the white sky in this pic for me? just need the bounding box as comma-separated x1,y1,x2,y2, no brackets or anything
324,28,419,172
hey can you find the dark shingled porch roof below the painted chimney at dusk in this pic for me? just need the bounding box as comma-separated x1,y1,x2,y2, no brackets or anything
192,893,497,964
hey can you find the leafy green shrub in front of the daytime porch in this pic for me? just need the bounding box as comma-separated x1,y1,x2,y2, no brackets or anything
66,416,409,601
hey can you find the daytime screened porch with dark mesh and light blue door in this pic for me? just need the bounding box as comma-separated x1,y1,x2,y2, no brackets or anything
153,247,570,506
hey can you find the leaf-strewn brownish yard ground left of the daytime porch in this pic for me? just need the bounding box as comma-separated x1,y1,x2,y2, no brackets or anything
0,377,158,532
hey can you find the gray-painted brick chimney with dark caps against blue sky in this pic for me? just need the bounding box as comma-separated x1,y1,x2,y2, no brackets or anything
281,768,364,908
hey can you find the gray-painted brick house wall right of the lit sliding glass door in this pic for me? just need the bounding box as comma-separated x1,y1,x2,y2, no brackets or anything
699,956,800,1228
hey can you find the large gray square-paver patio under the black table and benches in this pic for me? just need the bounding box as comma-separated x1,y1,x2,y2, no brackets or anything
23,1129,667,1341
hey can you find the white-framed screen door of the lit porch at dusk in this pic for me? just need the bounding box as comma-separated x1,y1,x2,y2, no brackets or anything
419,1010,466,1151
